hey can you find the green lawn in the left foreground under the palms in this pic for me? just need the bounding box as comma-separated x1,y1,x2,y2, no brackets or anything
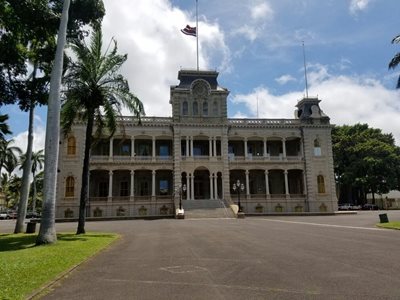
0,233,119,300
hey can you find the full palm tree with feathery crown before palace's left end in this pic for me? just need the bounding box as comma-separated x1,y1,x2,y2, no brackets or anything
61,27,144,234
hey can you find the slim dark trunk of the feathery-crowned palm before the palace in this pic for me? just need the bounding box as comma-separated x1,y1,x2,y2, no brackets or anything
76,110,94,234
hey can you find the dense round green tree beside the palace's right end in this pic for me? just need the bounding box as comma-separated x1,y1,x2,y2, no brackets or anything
332,124,400,202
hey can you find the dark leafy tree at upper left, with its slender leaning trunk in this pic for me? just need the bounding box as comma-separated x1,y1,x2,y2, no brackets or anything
0,0,104,237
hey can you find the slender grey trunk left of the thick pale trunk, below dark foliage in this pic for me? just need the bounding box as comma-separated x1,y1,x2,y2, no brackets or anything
14,102,35,233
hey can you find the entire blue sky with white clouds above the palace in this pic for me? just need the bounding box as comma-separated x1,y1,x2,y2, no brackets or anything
1,0,400,150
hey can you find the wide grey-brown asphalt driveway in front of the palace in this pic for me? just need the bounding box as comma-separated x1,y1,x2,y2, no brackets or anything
0,211,400,300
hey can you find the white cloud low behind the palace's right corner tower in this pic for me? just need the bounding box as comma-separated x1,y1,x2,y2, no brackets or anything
232,65,400,145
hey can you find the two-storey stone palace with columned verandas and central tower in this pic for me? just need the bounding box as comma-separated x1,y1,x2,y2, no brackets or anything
56,70,337,218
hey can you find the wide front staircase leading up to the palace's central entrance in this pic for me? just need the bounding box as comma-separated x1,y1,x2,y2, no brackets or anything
182,200,235,219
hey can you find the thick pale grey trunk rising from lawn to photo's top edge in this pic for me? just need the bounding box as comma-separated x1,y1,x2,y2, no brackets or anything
36,0,70,245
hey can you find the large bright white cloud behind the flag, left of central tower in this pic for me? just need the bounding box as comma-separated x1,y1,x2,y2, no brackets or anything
103,0,230,116
